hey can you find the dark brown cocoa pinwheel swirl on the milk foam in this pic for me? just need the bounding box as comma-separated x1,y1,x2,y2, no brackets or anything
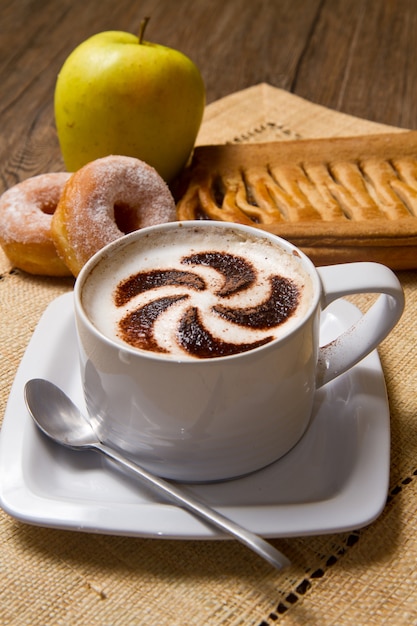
114,251,300,358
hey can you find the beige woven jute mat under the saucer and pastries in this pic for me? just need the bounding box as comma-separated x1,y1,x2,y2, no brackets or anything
0,85,417,626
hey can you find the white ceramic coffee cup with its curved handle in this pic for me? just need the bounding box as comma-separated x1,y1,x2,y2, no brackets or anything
75,221,404,481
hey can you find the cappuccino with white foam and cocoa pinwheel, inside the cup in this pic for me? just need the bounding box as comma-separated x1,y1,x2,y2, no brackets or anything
82,224,314,360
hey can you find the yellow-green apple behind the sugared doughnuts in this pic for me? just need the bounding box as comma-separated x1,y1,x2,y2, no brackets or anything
54,23,205,182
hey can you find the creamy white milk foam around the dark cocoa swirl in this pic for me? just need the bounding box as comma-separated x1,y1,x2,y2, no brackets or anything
82,226,313,359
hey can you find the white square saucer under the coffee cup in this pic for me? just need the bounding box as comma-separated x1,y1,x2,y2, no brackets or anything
0,293,390,539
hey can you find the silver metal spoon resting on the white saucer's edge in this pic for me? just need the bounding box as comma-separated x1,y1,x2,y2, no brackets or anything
24,378,290,569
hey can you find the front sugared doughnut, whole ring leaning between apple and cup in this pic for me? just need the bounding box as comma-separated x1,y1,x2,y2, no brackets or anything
52,155,176,276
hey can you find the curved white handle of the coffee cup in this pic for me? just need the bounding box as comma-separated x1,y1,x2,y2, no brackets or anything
316,262,404,387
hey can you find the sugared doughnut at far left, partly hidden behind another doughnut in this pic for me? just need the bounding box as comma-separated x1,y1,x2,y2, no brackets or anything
0,172,71,276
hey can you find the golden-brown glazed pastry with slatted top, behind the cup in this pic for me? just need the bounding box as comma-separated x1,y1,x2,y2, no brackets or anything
173,131,417,269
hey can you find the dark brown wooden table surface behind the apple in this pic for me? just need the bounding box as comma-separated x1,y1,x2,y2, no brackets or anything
0,0,417,192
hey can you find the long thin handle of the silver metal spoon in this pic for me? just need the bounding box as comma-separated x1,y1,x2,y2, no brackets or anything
94,443,290,569
